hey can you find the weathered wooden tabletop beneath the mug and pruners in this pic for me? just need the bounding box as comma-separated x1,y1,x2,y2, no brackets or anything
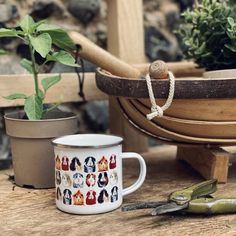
0,146,236,236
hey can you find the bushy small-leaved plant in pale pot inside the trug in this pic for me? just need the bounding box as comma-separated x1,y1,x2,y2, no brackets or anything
178,0,236,78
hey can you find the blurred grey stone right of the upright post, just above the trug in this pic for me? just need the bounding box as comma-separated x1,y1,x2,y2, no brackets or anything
145,26,180,62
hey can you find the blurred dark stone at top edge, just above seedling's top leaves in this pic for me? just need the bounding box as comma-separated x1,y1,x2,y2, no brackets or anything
30,0,64,20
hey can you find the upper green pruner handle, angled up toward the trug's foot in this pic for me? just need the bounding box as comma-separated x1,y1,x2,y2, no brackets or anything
168,180,217,205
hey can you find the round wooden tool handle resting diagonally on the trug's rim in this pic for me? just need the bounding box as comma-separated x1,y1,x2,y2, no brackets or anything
69,31,140,78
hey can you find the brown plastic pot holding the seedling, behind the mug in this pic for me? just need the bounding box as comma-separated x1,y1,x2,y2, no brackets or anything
5,111,77,188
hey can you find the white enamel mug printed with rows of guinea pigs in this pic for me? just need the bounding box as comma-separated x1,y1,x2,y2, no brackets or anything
52,134,146,214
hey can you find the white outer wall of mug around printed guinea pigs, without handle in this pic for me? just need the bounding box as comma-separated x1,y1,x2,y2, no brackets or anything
54,145,122,214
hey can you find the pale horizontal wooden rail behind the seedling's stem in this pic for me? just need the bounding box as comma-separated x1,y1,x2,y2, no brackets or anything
0,73,107,107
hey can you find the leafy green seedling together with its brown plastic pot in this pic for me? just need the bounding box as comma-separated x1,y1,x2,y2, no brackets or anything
0,15,78,188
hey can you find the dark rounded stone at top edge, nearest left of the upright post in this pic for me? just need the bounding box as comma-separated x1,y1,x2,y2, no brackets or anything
67,0,100,24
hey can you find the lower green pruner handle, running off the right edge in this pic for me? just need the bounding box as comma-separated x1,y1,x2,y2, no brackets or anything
184,198,236,215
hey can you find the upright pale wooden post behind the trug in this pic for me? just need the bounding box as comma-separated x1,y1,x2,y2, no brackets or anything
107,0,147,152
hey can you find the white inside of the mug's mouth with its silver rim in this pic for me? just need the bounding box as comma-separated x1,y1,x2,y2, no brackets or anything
53,134,123,147
